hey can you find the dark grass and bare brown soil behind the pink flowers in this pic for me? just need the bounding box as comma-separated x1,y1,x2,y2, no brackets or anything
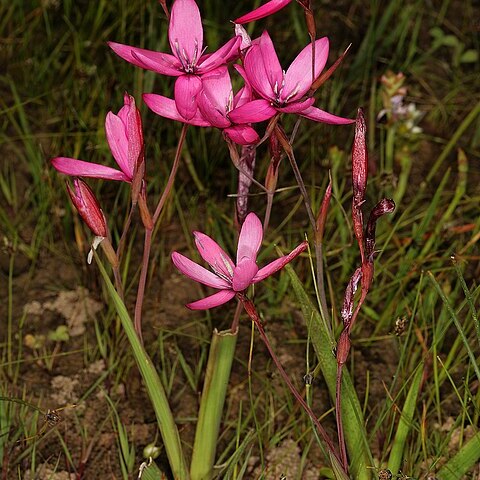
0,0,480,480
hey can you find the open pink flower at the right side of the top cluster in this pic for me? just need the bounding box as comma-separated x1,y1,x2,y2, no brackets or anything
230,31,354,125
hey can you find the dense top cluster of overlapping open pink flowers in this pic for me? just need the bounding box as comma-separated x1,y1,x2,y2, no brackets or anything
109,0,352,145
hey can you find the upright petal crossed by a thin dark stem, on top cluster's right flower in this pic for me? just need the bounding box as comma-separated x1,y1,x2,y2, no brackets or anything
281,37,329,101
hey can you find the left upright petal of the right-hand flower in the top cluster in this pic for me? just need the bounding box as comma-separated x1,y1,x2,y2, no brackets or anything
244,31,283,100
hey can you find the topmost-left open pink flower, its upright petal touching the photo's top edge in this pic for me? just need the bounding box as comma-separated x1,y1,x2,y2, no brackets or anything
109,0,241,120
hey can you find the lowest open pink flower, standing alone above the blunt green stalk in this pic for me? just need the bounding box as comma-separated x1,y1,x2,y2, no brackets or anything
172,213,307,310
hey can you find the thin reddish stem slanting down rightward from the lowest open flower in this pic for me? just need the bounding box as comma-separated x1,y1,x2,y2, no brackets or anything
237,293,340,468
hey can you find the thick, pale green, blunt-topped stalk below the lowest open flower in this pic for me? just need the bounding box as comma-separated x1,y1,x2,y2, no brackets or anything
190,330,238,480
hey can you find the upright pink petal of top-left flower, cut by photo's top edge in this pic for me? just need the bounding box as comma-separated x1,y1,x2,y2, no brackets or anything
168,0,203,66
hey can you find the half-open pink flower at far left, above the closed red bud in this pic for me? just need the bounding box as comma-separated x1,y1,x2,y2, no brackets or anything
52,93,144,183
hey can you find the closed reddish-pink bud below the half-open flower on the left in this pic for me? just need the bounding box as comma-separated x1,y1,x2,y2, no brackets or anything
67,178,108,238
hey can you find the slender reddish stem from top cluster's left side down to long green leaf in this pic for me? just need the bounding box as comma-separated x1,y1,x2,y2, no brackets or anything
134,124,188,343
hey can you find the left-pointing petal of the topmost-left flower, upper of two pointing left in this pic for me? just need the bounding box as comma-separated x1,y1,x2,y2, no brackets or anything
108,42,183,77
